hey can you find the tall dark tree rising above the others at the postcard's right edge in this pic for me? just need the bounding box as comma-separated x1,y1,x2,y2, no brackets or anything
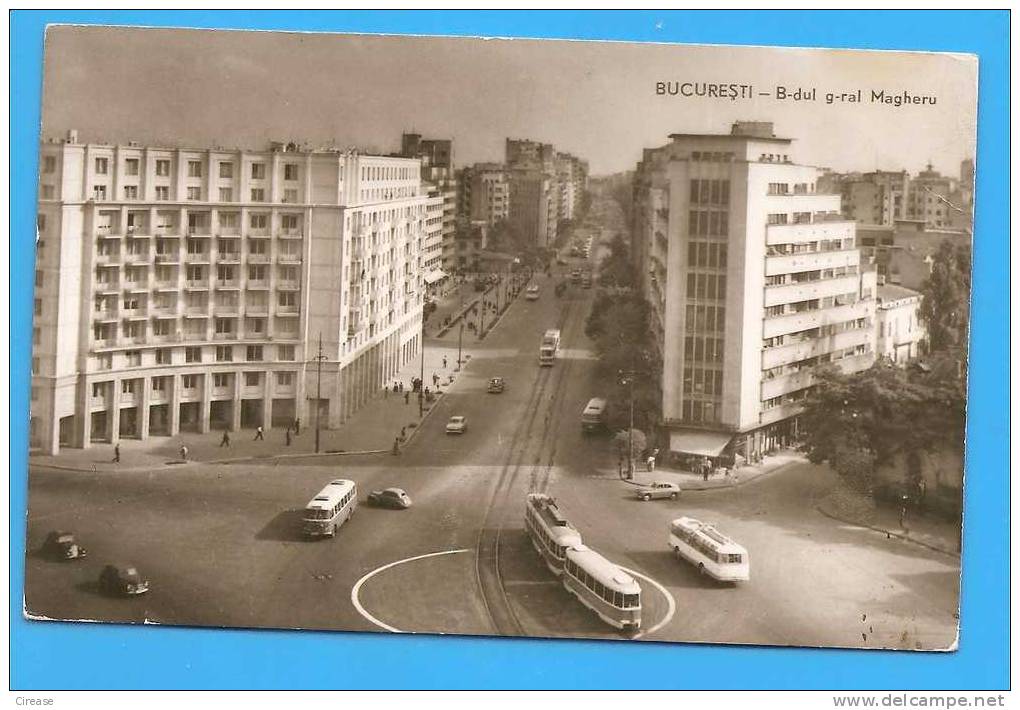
921,241,971,351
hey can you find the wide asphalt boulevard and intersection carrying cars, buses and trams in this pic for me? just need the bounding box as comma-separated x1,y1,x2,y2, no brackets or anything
26,192,960,649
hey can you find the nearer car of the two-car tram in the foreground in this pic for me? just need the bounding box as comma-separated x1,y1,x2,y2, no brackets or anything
563,545,641,631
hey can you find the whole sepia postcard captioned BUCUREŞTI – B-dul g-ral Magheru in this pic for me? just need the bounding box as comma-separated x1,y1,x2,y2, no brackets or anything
22,24,980,652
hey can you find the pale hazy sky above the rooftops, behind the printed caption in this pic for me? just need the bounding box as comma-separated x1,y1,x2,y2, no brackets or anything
42,27,977,175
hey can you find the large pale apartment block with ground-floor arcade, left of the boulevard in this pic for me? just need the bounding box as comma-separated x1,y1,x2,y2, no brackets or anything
31,132,427,453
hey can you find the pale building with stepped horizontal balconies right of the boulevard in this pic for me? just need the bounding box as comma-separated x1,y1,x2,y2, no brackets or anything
632,121,876,457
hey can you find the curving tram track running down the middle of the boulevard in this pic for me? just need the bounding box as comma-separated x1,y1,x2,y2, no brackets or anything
475,287,577,637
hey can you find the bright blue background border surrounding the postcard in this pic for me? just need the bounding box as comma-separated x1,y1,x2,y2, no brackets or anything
10,10,1010,690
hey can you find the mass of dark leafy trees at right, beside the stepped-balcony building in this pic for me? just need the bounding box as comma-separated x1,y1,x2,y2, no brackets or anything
801,242,971,518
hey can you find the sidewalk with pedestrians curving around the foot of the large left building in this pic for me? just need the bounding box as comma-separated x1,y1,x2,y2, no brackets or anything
29,341,470,471
